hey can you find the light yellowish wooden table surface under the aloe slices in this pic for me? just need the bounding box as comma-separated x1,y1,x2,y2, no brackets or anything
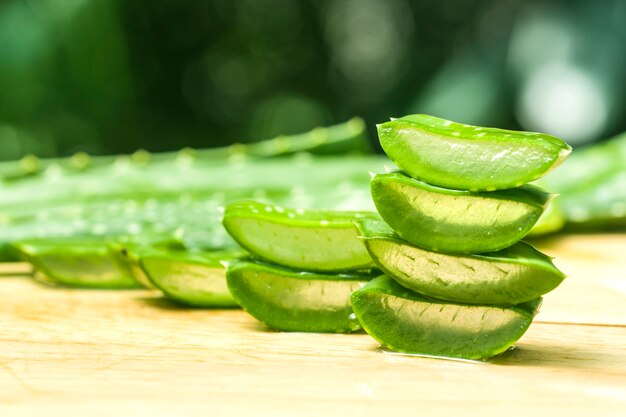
0,234,626,417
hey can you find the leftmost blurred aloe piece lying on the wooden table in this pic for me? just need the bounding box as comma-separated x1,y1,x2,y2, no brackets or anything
15,239,139,289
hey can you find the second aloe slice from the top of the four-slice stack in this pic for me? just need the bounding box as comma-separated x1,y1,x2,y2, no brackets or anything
371,172,552,253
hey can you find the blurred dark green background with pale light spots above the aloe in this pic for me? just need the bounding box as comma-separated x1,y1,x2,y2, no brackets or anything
0,0,626,159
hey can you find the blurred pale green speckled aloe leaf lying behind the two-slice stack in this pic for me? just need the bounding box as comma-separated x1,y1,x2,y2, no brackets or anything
0,155,388,260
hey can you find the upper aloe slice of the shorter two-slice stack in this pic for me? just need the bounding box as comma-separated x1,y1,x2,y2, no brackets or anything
223,201,379,271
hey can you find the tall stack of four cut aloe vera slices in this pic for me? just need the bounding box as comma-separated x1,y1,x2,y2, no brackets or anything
352,115,571,359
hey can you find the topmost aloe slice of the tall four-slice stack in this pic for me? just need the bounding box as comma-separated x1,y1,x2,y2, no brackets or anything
378,114,572,191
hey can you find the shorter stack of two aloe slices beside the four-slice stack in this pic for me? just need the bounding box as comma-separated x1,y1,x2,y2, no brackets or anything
223,200,380,333
